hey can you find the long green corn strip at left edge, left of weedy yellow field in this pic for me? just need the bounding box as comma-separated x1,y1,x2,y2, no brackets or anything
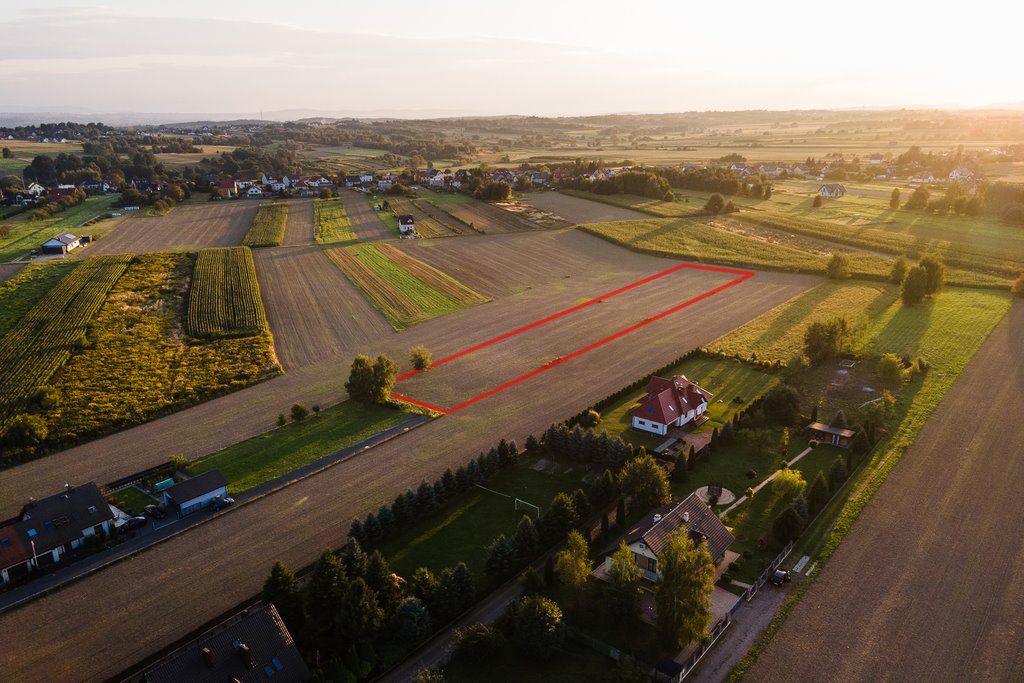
0,256,130,427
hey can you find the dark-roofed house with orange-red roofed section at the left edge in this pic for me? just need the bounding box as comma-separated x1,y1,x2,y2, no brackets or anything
0,482,114,584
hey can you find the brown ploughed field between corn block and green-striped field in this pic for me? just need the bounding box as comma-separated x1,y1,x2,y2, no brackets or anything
253,247,394,370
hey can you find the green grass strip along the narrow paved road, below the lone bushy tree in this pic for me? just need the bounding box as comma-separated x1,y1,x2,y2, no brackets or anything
188,400,411,494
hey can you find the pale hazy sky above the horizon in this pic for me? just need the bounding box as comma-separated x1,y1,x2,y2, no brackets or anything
0,0,1024,116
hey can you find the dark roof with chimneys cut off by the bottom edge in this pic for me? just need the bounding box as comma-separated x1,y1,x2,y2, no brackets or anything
144,604,309,683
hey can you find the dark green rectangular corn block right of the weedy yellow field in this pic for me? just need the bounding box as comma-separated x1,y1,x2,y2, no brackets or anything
186,247,268,339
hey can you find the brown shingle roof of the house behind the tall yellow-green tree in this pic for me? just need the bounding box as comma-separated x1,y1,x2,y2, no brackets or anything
626,494,735,562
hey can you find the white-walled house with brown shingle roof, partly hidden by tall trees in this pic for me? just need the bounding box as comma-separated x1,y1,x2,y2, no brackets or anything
604,494,735,581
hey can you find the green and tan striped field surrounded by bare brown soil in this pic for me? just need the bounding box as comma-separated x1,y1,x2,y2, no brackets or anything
328,245,487,330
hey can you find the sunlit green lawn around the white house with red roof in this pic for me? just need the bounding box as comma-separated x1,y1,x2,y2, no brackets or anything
598,356,779,451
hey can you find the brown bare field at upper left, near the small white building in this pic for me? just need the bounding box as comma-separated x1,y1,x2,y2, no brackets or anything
84,201,257,256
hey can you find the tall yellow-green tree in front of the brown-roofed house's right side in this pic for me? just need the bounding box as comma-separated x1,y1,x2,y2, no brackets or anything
654,529,715,651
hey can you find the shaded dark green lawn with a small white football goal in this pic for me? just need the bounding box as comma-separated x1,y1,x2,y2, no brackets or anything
381,457,585,591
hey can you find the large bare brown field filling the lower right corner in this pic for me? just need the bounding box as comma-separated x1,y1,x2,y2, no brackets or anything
749,303,1024,681
